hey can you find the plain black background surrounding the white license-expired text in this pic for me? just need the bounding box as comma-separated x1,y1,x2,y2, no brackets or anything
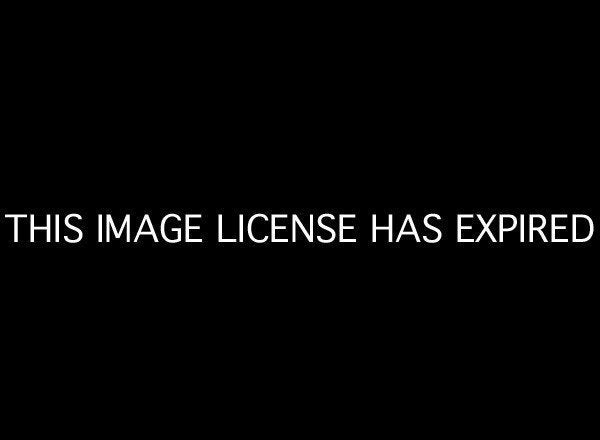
1,5,598,433
